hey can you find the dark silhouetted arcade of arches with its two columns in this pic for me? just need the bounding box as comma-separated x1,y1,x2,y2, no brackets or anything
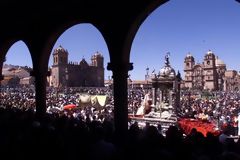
0,0,171,138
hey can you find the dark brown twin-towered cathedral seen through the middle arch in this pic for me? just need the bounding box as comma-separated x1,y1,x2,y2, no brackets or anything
49,46,104,87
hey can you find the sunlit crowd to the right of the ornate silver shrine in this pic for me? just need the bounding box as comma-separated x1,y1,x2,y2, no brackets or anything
181,91,240,135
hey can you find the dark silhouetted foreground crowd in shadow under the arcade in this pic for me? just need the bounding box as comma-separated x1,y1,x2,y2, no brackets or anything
0,105,240,160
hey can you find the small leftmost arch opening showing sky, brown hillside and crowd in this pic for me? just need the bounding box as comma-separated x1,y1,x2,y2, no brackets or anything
1,41,36,111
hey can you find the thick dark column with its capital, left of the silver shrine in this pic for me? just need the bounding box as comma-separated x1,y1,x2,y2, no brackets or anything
107,63,133,143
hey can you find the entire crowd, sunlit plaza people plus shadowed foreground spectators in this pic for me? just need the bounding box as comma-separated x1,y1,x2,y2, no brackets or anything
0,88,240,160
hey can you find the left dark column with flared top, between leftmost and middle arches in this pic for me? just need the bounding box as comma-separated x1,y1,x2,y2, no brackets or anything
24,35,56,120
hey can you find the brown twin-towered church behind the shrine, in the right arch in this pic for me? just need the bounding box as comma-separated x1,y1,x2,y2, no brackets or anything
184,50,226,90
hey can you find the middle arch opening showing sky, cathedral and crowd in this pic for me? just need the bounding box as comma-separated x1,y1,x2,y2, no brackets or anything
47,24,113,117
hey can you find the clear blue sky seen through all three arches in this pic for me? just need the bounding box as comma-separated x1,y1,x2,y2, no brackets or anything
6,0,240,80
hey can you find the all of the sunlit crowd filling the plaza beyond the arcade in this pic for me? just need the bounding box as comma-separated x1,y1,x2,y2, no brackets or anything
0,87,240,132
